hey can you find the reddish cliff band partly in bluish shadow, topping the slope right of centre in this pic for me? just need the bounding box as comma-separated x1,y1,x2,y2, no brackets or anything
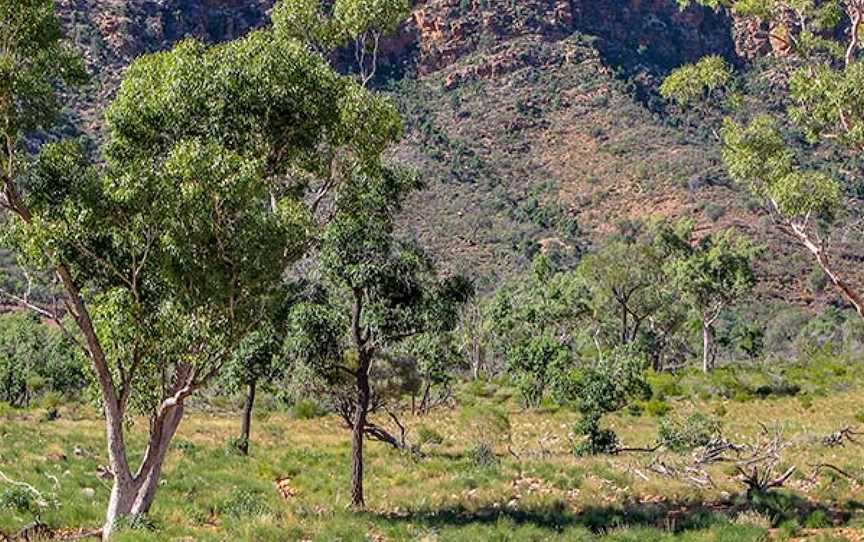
412,0,735,73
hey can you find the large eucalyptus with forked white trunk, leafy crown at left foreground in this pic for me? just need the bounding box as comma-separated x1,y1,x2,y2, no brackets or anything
0,0,399,539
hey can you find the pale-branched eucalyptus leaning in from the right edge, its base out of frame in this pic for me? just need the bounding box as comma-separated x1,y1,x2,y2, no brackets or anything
661,0,864,318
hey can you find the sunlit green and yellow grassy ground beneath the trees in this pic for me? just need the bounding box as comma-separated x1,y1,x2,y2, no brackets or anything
0,376,864,542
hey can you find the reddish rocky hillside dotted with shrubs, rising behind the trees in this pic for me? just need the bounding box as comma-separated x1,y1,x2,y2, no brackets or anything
52,0,852,303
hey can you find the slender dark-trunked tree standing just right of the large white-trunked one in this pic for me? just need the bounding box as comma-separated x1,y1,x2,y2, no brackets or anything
286,169,472,508
